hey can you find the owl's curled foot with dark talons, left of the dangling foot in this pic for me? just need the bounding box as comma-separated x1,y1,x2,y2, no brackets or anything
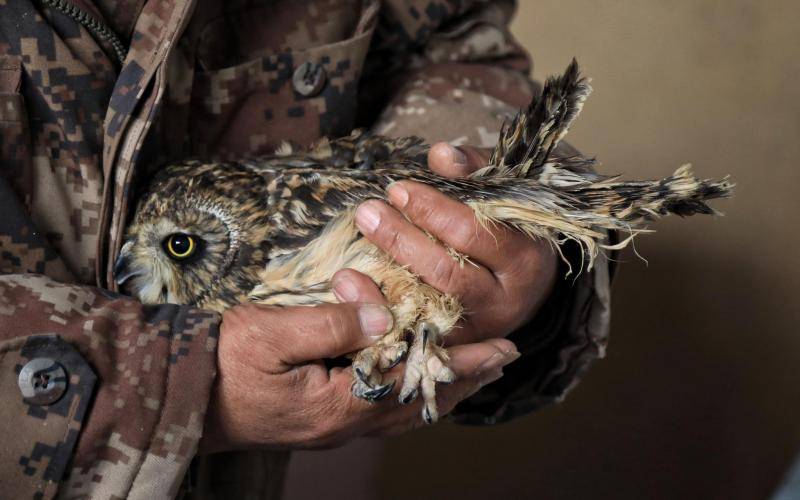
351,341,408,403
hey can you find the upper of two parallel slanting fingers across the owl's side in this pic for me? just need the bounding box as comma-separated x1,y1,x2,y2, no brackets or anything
387,181,531,273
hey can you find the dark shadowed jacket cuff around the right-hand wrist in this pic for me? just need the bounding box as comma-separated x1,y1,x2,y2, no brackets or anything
452,237,614,425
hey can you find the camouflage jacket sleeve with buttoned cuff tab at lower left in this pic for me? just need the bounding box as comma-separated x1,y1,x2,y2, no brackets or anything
0,177,219,498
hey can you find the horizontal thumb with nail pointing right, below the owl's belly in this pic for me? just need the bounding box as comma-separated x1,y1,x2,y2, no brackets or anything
239,303,393,365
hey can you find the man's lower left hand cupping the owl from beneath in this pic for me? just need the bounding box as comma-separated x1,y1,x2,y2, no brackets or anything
200,278,519,453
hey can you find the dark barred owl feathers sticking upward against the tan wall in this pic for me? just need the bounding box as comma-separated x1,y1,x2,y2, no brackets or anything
474,59,592,177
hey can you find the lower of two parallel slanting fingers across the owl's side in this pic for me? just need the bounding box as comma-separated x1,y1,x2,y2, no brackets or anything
356,200,494,296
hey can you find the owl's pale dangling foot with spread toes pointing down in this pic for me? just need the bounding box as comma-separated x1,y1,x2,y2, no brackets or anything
400,322,456,424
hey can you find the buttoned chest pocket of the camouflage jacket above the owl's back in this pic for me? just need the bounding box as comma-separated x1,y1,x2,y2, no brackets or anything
189,1,379,158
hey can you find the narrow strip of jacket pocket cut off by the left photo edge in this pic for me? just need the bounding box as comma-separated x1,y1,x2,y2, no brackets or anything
0,56,31,209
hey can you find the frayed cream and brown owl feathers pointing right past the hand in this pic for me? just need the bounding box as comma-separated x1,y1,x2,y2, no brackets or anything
468,165,733,269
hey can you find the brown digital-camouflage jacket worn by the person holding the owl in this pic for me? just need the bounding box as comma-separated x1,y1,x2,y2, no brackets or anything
0,0,609,498
